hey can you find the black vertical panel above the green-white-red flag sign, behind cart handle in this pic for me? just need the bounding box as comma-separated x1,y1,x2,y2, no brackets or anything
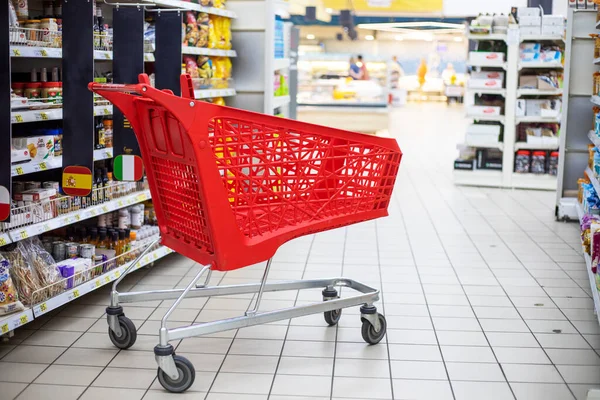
113,7,144,157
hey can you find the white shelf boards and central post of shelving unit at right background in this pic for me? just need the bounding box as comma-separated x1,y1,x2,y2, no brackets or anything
454,25,563,190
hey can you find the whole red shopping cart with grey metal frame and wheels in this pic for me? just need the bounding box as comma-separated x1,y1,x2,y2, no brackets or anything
89,74,401,392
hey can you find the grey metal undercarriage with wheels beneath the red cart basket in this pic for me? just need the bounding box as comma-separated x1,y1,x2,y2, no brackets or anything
106,239,387,391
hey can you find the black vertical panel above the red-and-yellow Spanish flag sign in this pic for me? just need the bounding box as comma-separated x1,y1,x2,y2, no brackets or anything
62,0,94,175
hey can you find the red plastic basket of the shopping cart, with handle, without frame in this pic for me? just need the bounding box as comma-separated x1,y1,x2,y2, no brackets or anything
89,74,402,271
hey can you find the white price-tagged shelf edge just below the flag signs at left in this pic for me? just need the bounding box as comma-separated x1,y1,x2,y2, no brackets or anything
0,190,151,247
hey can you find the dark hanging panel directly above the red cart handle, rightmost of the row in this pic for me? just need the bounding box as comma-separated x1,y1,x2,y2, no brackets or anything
154,11,182,96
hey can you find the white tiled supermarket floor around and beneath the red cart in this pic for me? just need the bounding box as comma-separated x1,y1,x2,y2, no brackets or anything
0,105,600,400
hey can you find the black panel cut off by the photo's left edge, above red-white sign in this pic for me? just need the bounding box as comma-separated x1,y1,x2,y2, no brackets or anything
0,5,12,220
